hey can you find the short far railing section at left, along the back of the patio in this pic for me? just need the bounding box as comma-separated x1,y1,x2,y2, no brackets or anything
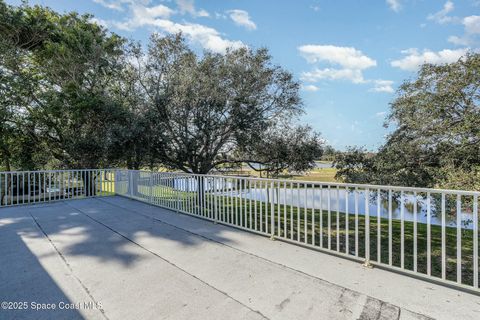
0,169,115,207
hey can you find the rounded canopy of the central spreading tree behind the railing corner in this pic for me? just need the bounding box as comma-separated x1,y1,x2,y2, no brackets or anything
126,35,316,173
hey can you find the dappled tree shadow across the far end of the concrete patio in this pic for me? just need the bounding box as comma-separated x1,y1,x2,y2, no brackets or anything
0,197,232,268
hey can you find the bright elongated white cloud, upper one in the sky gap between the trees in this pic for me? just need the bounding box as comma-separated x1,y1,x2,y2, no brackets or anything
298,45,377,70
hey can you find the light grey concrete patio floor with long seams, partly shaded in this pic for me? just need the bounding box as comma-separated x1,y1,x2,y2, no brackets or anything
0,197,480,319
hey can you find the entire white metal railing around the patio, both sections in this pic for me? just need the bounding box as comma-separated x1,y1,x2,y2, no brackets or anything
0,169,480,292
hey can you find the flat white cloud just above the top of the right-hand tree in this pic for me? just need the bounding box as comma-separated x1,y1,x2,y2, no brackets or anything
390,48,468,71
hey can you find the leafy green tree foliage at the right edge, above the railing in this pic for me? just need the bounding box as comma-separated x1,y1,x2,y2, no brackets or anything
336,53,480,189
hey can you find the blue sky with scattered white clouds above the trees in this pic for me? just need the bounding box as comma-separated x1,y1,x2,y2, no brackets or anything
7,0,480,150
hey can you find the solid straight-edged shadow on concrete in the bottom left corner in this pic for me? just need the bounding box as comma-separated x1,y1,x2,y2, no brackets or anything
0,209,83,319
